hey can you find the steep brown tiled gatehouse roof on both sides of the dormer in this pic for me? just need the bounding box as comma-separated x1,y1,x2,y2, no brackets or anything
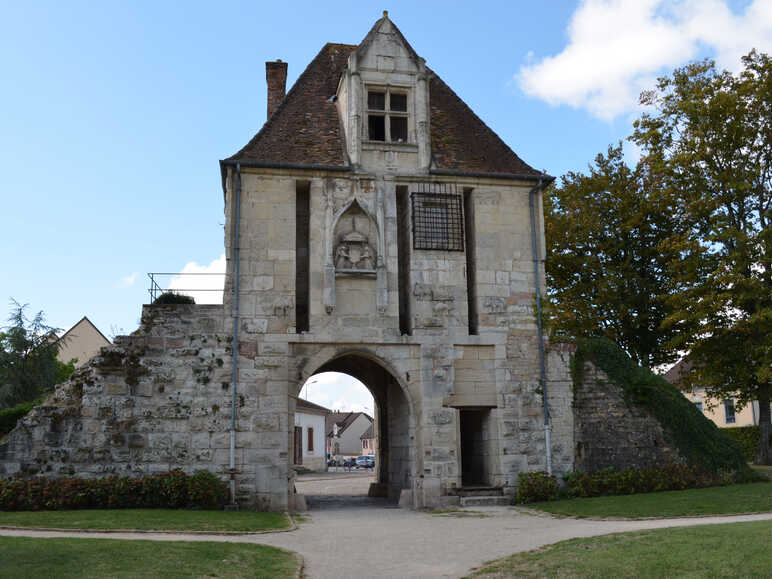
226,39,542,177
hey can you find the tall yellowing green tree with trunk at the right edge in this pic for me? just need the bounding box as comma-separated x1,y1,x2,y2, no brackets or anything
631,51,772,464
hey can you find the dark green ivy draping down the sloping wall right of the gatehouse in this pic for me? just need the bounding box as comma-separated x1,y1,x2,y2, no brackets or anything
571,338,749,476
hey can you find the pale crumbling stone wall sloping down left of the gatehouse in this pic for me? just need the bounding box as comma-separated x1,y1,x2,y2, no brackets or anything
0,305,247,500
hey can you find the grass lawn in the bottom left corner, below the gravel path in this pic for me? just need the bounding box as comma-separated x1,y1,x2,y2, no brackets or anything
0,537,298,579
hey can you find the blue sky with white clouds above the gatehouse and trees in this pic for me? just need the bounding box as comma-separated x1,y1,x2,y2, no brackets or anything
0,0,772,410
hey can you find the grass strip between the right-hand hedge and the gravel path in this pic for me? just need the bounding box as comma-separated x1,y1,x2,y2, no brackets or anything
527,482,772,518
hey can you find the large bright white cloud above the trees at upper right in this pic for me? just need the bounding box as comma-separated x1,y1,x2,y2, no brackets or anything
516,0,772,120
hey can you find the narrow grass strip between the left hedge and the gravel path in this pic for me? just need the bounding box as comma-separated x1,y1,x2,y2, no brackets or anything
0,509,289,532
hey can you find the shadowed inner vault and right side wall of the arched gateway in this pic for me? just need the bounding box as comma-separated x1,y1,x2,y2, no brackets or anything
290,353,415,506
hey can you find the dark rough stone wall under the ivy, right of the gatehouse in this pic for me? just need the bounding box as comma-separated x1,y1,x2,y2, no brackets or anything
574,362,682,472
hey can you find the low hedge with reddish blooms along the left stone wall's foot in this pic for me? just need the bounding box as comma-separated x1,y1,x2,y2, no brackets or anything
0,469,228,511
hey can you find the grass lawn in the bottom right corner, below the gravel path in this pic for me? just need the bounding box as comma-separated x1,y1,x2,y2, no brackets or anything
472,521,772,577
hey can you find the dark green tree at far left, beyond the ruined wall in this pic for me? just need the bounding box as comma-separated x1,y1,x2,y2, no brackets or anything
0,300,74,409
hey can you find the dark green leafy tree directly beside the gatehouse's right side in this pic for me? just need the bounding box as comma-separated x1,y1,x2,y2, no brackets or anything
544,144,688,367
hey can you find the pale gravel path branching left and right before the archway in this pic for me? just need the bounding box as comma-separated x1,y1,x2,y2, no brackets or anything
0,505,772,578
